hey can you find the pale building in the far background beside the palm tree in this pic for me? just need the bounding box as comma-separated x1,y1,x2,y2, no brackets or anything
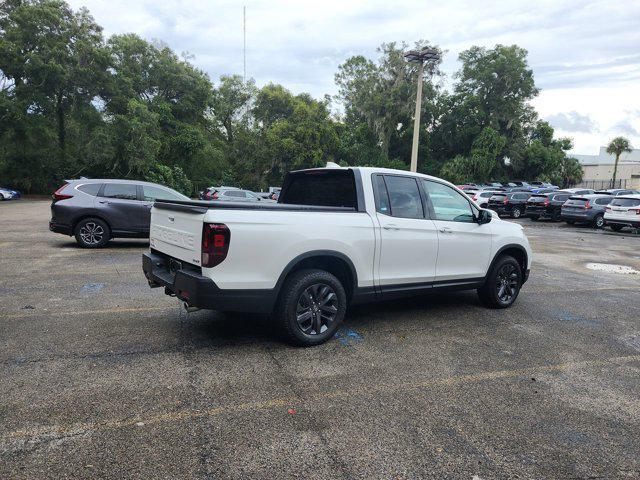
570,147,640,188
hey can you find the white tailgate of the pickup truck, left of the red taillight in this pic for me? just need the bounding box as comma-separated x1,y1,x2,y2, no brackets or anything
149,203,207,265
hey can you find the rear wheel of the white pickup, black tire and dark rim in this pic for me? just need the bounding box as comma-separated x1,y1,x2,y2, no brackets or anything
275,269,347,347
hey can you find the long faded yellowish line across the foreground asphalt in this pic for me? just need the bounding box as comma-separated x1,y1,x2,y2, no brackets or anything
6,355,640,450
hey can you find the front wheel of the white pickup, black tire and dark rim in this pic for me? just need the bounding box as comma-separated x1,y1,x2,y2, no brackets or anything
478,255,522,308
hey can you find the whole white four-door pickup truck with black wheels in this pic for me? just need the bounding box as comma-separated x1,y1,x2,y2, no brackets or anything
143,167,531,346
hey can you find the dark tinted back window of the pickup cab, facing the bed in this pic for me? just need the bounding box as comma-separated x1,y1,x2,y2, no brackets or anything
278,169,358,208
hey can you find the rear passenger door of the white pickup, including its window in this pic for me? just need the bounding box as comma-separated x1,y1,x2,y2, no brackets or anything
372,174,438,288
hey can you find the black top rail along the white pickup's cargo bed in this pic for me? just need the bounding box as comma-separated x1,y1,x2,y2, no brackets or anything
153,199,357,213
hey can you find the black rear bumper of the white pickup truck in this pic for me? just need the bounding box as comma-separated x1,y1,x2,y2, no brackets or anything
142,252,276,313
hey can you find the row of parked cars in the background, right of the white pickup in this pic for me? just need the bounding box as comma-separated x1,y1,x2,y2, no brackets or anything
482,188,640,231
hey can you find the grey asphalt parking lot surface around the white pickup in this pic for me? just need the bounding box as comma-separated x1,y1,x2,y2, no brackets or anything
0,200,640,479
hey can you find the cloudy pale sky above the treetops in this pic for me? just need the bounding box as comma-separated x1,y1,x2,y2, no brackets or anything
67,0,640,154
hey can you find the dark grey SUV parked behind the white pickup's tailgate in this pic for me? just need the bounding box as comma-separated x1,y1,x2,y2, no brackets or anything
49,179,189,248
